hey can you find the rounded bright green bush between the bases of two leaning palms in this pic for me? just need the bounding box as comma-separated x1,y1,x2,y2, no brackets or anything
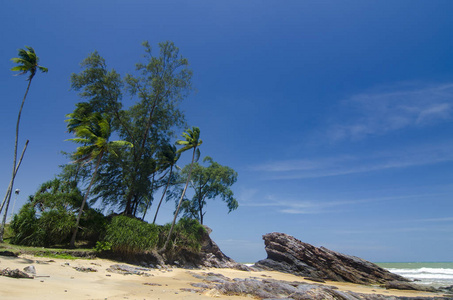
104,216,159,257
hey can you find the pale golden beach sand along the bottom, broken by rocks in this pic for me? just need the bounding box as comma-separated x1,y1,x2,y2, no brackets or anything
0,255,439,300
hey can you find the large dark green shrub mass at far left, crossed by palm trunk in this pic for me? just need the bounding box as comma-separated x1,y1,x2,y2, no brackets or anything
11,179,106,247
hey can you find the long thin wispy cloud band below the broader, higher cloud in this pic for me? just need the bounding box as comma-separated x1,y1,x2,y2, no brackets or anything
250,143,453,180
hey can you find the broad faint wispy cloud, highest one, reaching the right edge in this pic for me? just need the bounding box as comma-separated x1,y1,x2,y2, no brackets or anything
327,83,453,141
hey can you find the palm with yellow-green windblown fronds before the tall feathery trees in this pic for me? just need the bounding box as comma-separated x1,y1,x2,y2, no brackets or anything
66,113,132,248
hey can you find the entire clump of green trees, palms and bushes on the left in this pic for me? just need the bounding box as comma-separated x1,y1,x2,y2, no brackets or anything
1,42,238,258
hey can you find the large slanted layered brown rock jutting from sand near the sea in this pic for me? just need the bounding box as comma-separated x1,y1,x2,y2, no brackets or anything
255,232,409,285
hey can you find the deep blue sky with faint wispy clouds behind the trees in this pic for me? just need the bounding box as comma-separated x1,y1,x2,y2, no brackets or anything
0,0,453,262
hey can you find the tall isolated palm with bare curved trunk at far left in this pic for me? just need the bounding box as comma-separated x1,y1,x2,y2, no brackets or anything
0,46,48,242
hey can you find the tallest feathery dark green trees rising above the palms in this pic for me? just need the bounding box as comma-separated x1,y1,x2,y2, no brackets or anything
68,42,192,216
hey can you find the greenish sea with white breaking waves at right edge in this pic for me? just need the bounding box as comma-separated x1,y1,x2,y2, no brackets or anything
377,262,453,287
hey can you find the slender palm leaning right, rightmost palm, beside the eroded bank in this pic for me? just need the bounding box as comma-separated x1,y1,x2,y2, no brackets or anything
161,127,203,252
